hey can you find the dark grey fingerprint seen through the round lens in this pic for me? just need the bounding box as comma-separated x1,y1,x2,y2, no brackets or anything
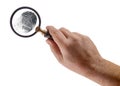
21,11,37,33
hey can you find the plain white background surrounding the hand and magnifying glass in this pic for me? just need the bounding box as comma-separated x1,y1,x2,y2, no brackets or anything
0,0,120,86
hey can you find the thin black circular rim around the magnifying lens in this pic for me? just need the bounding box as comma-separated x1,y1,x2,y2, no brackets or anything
10,6,41,38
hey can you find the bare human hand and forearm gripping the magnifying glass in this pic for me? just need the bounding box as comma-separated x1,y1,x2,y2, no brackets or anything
46,26,120,86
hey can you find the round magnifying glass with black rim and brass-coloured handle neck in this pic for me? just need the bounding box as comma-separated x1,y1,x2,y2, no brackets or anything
10,7,52,38
